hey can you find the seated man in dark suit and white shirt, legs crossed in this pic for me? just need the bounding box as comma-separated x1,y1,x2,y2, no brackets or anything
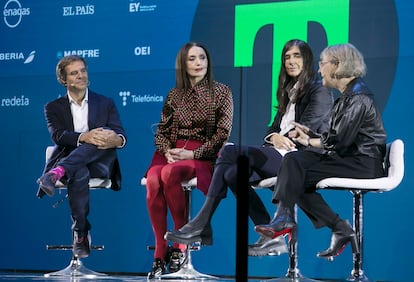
37,55,126,258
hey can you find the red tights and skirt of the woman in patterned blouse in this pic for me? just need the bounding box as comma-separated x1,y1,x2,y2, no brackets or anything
146,140,213,260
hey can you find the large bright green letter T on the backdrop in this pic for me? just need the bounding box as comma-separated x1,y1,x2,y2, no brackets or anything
234,0,350,120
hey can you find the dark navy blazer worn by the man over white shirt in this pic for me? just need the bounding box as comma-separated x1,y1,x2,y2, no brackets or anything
37,90,126,198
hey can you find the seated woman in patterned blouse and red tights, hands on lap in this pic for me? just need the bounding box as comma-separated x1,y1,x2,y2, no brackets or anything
146,42,233,278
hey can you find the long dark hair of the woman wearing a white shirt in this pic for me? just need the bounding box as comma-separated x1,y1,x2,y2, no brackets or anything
276,39,315,114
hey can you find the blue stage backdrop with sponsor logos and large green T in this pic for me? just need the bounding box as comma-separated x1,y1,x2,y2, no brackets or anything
0,0,414,281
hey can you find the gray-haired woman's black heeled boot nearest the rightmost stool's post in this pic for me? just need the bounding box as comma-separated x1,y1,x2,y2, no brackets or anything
317,220,359,259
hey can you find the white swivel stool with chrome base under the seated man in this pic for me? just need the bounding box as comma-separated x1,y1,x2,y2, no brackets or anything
44,146,112,279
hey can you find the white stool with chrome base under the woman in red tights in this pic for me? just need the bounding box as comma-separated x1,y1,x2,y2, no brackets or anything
141,177,218,279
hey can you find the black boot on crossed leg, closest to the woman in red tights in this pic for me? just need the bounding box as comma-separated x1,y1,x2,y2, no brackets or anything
164,196,221,245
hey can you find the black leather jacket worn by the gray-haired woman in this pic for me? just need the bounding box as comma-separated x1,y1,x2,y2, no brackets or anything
321,78,386,159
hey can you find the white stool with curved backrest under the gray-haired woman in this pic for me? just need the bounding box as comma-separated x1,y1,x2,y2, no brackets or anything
316,139,404,281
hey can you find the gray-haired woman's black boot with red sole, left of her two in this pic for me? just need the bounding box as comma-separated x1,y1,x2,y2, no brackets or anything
254,204,296,239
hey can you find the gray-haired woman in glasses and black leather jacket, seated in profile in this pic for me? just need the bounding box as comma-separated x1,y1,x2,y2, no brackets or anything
255,44,386,258
